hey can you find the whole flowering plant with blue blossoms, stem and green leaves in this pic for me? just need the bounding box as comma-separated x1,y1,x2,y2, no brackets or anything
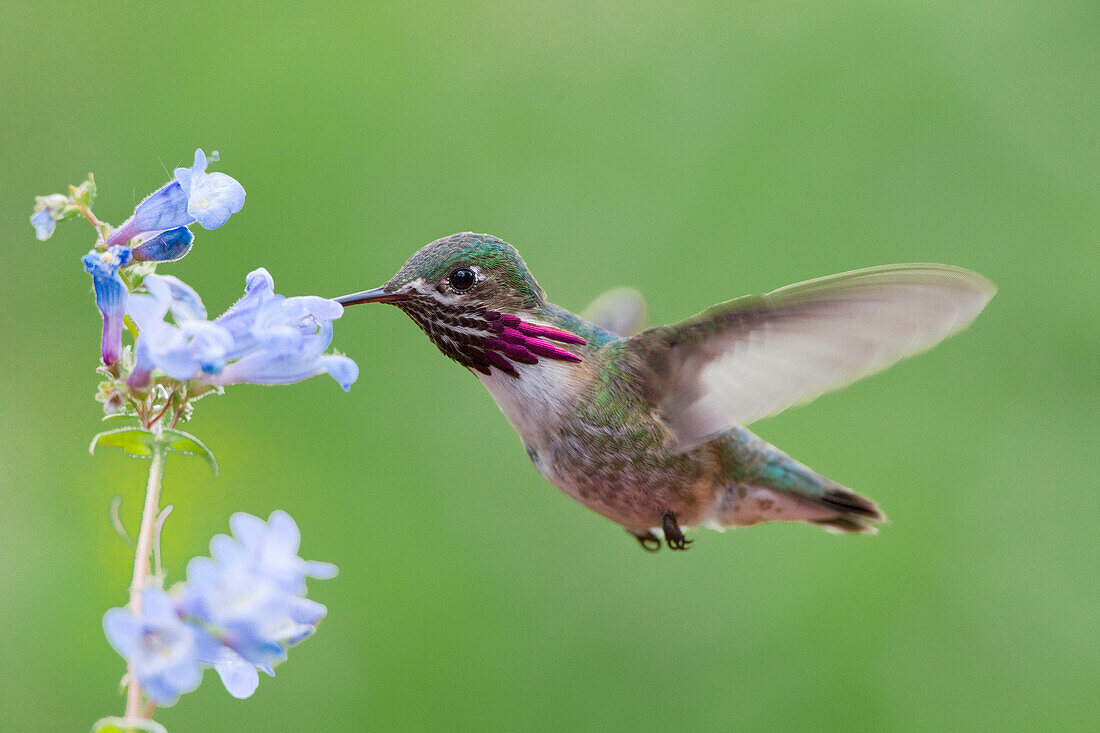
31,150,359,731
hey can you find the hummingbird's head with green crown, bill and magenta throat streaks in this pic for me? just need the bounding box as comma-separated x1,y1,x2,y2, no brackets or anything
336,232,586,376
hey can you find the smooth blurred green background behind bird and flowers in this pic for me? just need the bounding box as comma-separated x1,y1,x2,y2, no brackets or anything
0,0,1100,731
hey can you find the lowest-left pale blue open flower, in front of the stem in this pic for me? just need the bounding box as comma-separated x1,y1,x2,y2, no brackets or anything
103,588,212,705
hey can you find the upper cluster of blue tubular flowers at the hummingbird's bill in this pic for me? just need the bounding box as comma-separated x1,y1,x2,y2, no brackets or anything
72,150,359,390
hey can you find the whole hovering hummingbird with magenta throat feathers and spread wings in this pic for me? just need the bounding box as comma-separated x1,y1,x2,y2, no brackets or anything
336,232,997,551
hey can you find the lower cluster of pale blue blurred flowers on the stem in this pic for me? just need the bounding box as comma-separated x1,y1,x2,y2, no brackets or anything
103,512,337,705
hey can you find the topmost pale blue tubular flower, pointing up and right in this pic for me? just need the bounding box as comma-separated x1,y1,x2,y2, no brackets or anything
107,149,244,249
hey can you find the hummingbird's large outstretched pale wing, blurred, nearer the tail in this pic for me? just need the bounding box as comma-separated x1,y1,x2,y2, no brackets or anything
628,259,997,450
